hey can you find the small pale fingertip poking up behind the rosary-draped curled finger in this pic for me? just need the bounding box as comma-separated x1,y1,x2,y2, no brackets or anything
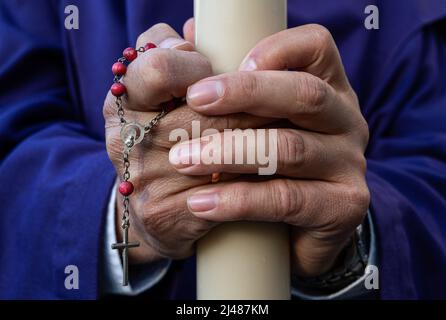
136,23,194,51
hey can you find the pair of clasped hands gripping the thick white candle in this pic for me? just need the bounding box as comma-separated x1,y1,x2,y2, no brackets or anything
103,20,370,276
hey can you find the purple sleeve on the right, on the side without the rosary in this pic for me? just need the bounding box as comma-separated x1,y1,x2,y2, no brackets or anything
366,22,446,299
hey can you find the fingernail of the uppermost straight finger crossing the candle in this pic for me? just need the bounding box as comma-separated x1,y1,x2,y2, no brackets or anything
187,80,225,106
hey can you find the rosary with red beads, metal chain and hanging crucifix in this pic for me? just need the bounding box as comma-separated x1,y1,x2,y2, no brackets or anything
110,42,175,286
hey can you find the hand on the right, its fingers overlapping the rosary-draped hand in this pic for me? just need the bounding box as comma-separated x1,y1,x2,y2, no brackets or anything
170,25,370,276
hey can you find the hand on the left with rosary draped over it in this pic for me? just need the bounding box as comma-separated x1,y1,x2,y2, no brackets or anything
103,22,270,263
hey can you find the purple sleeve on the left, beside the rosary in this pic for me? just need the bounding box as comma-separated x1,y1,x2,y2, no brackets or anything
0,1,115,299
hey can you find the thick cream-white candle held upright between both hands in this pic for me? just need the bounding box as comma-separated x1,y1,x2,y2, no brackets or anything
194,0,290,299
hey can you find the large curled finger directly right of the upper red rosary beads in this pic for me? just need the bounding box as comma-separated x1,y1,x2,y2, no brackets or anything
123,48,212,111
